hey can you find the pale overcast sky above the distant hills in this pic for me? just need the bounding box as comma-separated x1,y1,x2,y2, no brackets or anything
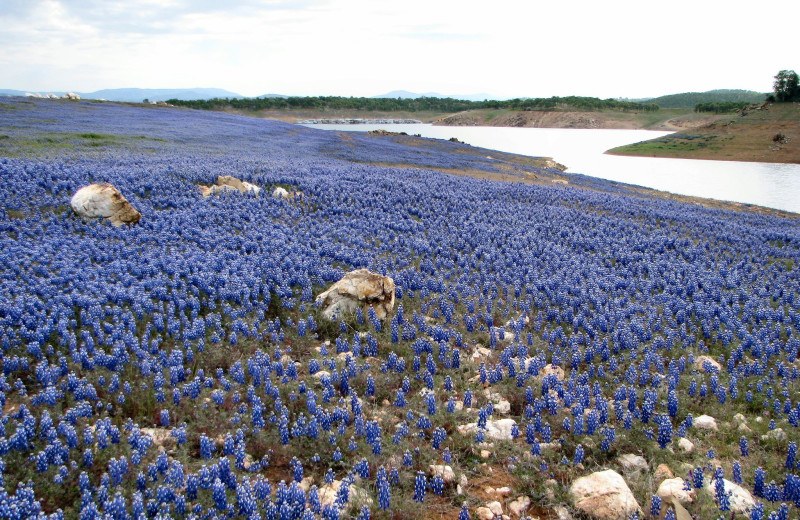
0,0,800,99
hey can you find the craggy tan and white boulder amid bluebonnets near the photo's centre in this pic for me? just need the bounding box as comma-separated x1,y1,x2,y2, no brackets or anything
317,269,394,320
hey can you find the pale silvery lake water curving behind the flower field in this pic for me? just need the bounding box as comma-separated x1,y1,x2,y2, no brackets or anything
307,124,800,213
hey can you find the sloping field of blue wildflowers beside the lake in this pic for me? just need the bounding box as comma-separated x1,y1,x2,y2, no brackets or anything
0,99,800,520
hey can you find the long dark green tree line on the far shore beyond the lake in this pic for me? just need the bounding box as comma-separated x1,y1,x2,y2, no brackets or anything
167,96,658,112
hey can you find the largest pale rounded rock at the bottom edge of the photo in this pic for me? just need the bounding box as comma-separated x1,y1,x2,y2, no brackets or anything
569,469,640,520
